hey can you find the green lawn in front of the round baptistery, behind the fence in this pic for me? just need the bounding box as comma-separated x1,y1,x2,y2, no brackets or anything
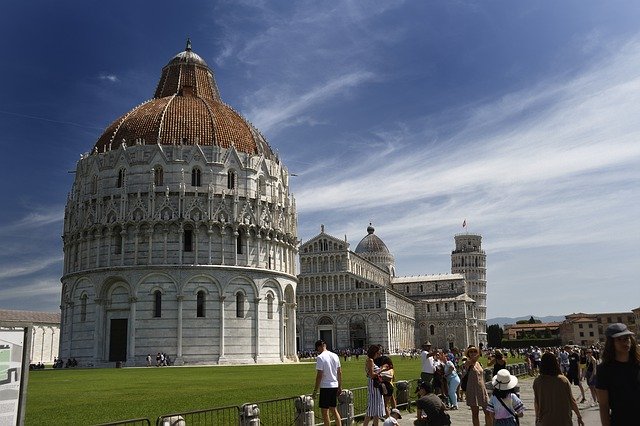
25,357,516,425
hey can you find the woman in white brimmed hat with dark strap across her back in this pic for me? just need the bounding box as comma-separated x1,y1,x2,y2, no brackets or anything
487,368,524,426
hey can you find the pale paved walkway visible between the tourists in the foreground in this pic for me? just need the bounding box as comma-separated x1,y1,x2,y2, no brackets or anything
388,378,600,426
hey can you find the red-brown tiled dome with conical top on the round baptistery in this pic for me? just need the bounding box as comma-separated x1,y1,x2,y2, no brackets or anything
95,41,274,158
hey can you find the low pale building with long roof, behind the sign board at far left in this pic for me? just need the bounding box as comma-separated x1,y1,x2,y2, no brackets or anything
0,309,60,364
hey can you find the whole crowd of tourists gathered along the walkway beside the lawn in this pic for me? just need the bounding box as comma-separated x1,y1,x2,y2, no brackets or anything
307,323,640,426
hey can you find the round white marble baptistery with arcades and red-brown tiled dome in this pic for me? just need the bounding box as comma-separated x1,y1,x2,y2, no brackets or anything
60,42,298,366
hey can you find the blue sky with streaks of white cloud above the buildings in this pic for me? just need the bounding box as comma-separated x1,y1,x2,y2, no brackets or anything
0,0,640,318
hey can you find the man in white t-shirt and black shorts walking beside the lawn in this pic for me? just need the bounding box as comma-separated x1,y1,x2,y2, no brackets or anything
313,340,342,426
